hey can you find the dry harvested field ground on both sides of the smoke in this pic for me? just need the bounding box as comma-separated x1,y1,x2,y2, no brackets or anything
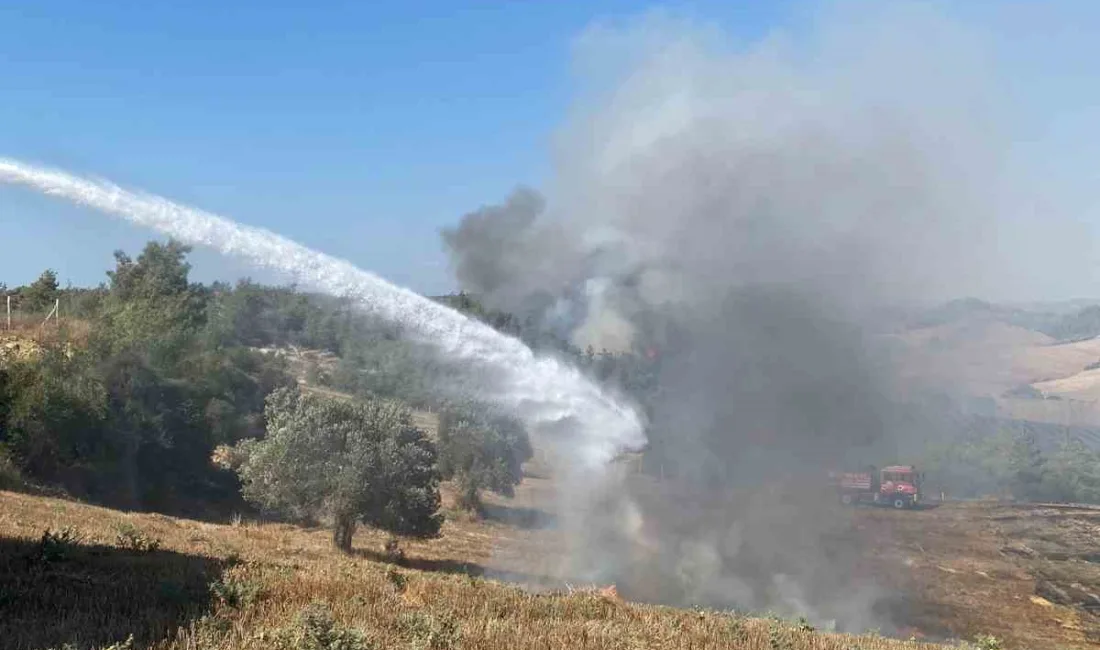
0,478,1100,650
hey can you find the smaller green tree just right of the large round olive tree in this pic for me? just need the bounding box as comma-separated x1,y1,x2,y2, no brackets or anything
439,406,531,510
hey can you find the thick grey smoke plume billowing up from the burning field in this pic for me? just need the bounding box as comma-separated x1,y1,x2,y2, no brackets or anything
444,4,1086,627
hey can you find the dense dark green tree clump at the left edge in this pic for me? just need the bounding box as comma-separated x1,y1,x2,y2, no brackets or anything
0,242,294,513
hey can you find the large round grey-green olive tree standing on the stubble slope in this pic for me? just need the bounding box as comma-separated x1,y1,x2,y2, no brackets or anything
228,388,443,551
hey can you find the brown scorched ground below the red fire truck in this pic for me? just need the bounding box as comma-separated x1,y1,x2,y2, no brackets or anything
857,504,1100,648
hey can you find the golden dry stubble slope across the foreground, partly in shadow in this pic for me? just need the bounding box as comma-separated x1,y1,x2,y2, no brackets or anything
0,493,963,650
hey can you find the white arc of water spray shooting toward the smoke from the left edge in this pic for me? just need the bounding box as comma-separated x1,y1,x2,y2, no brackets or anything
0,158,645,469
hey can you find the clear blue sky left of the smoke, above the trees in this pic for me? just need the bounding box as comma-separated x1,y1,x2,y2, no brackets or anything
0,0,1097,293
